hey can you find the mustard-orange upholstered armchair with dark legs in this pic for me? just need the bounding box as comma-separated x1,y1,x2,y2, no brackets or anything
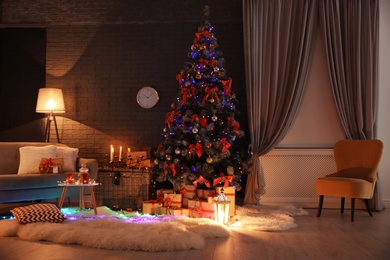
316,140,383,221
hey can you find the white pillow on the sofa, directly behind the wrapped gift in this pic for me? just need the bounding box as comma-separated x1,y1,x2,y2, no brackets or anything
18,145,57,174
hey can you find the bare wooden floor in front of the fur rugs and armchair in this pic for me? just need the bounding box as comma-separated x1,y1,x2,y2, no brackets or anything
0,209,390,260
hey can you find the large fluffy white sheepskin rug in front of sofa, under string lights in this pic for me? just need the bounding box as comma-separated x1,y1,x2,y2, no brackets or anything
0,206,230,251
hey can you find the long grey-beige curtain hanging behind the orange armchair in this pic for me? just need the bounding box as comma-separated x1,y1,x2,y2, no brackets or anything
319,0,384,210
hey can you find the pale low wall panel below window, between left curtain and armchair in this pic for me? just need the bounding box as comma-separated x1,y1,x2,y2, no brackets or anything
260,149,336,207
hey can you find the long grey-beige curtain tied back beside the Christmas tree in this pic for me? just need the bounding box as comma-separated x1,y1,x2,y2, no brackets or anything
243,0,318,204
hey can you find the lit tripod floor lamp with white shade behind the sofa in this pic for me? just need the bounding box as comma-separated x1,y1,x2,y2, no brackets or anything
35,88,65,143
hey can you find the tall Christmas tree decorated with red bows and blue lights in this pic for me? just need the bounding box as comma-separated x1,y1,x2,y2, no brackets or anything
154,6,249,193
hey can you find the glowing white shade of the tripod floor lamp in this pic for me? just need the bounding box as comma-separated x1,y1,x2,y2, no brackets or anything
35,88,65,113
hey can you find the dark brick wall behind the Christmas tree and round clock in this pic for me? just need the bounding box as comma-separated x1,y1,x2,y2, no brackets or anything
0,0,249,166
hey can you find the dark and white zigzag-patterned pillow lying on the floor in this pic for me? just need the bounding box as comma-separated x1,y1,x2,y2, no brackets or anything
11,203,65,224
